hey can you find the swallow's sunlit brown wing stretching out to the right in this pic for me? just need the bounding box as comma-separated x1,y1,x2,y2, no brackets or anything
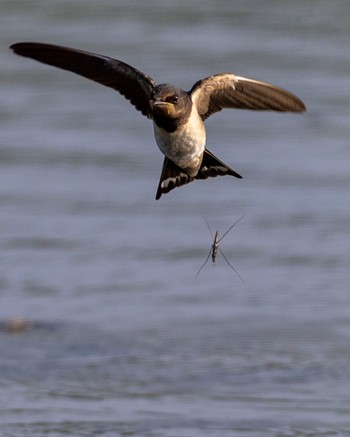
189,73,306,120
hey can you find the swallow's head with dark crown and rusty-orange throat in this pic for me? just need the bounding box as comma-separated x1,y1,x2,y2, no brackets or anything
150,84,191,119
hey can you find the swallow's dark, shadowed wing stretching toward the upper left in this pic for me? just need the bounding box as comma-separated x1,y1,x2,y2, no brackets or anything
10,42,155,118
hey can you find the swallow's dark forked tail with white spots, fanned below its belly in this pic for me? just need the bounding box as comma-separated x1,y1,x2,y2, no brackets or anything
156,149,242,200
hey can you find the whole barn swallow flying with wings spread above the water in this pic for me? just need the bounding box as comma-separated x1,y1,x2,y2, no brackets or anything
10,42,306,199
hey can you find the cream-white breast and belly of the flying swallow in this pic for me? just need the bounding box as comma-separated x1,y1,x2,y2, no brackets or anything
153,105,206,168
